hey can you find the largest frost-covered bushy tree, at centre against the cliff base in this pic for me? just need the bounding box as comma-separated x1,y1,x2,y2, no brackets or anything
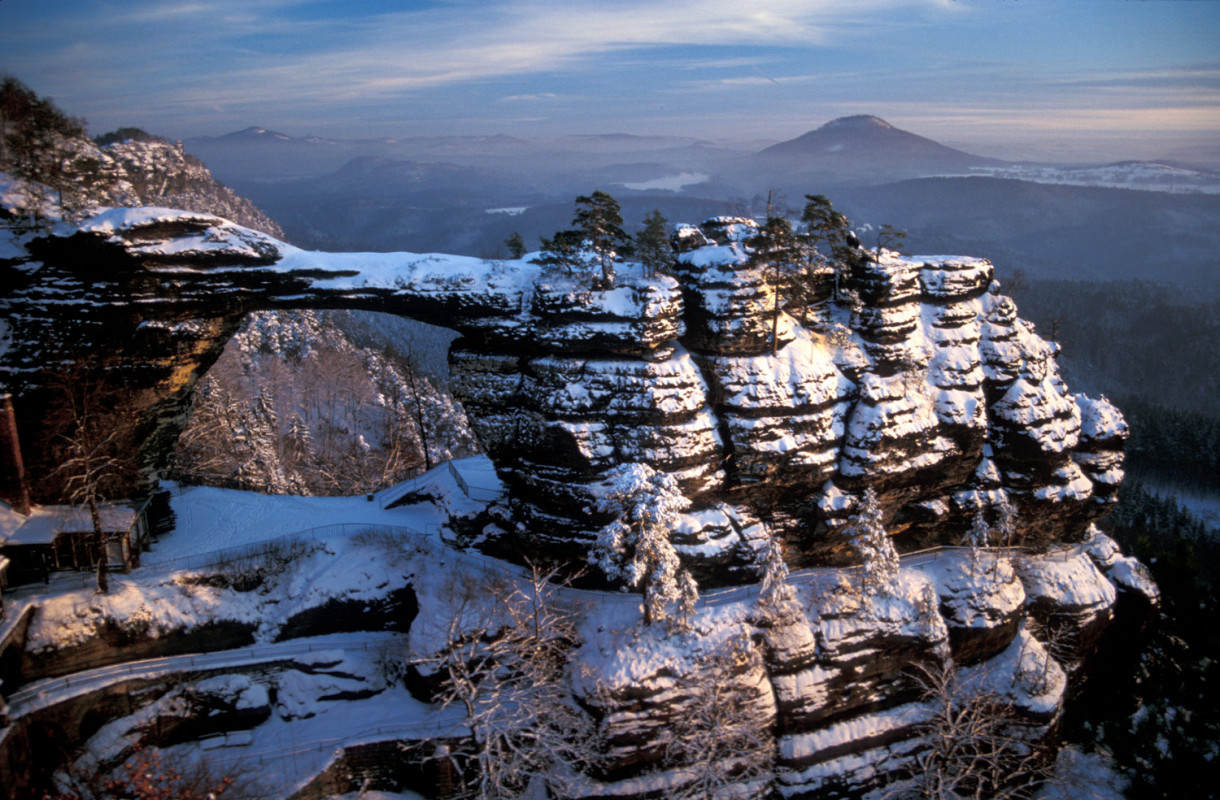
589,463,699,629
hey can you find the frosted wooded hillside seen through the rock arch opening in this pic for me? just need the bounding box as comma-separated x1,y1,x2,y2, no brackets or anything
173,311,478,495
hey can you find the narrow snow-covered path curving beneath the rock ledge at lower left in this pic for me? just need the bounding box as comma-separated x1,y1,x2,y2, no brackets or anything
9,630,405,718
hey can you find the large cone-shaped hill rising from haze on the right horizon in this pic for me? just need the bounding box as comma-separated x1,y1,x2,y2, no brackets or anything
752,115,1004,184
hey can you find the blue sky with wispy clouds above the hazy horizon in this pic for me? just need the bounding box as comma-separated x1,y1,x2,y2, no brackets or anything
0,0,1220,157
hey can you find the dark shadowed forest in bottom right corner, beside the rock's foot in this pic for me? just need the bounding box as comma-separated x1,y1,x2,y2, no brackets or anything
1078,480,1220,800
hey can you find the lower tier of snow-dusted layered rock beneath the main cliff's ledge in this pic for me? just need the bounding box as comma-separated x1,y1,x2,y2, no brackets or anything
561,551,1114,800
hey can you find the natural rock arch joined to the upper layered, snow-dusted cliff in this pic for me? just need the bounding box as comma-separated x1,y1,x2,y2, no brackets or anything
0,209,1126,570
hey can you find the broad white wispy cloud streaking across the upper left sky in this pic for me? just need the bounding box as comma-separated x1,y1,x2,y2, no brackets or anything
2,0,921,101
